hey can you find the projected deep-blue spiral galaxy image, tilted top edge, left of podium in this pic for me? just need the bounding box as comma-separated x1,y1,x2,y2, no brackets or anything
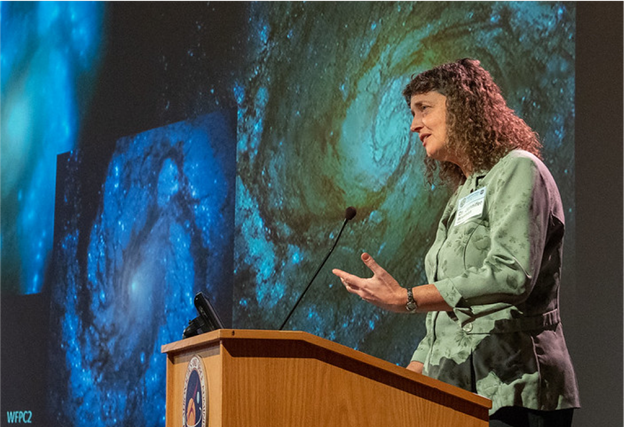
51,113,235,425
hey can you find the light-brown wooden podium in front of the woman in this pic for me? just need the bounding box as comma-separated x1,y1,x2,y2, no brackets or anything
162,329,491,427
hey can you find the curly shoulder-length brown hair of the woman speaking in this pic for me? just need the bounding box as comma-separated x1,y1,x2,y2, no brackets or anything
403,58,542,185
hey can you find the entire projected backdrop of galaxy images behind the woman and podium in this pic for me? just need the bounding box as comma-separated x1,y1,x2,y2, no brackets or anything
0,0,576,426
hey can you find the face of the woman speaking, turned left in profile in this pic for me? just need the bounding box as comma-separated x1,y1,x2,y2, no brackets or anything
410,92,461,166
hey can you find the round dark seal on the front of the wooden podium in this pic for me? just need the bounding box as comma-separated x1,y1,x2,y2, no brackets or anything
182,355,208,427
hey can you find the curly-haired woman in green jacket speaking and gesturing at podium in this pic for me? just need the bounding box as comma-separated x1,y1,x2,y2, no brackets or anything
333,59,579,426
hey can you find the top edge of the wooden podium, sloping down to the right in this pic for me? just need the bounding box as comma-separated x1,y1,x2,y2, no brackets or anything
161,329,492,409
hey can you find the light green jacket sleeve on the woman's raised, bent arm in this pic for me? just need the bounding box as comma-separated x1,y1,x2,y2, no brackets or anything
434,156,558,308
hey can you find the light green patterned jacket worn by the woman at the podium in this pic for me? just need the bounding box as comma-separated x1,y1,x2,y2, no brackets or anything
412,150,579,413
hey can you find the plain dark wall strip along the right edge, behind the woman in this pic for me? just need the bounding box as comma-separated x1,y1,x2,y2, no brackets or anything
563,0,624,426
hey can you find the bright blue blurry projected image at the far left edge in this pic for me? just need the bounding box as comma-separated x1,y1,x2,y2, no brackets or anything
0,0,104,294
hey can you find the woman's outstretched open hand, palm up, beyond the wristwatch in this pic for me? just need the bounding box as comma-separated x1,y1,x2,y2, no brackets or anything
332,253,407,313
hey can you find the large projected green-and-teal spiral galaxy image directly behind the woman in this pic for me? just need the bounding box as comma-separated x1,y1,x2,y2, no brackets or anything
234,1,574,365
